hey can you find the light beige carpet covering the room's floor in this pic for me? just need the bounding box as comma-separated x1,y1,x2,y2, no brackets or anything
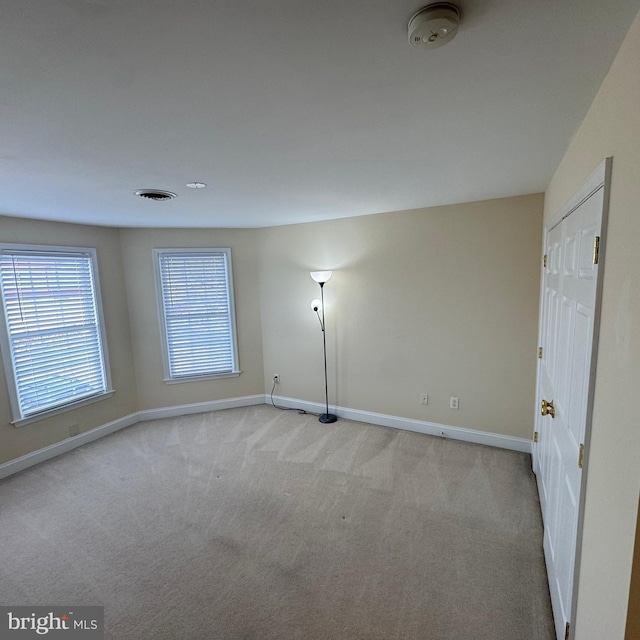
0,405,553,640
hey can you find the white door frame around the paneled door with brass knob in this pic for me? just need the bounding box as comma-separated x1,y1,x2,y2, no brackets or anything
532,157,613,638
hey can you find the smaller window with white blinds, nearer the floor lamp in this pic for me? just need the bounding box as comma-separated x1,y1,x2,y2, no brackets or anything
154,249,240,382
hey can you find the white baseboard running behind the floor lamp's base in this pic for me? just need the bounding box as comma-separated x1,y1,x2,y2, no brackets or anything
265,394,532,453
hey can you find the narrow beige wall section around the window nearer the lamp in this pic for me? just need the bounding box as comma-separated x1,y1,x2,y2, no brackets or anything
120,229,264,409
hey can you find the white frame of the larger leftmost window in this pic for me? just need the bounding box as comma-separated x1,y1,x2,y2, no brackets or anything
0,243,114,427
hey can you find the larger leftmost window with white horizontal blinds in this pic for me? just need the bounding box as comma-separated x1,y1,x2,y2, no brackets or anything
0,245,111,424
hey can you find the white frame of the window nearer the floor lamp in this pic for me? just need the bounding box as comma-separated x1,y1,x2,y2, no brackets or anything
153,247,241,384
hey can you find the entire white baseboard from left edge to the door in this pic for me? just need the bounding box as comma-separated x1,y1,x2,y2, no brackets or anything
0,394,532,479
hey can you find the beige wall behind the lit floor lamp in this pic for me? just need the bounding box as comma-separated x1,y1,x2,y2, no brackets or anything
260,195,542,438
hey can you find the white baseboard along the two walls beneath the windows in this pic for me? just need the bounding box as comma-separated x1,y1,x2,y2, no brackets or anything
0,394,264,480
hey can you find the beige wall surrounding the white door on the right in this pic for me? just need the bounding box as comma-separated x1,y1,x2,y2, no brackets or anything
545,7,640,640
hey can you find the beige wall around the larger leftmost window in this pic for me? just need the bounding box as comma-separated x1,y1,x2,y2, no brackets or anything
0,217,137,463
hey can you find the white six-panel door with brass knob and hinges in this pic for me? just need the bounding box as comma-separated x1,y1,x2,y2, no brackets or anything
533,163,610,640
